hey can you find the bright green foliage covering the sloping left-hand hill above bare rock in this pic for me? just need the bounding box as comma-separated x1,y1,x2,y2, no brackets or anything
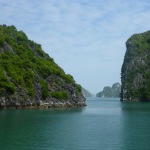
0,25,81,99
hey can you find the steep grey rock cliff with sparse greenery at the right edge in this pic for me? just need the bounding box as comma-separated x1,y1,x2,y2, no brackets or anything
121,31,150,101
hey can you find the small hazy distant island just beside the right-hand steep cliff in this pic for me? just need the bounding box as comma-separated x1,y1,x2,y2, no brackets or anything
96,82,121,98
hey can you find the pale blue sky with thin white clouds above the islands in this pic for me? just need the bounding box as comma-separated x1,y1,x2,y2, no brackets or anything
0,0,150,94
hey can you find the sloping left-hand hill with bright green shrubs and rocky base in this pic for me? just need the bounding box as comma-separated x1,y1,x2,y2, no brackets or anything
0,25,85,108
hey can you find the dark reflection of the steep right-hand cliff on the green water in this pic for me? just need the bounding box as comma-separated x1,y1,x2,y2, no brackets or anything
121,102,150,150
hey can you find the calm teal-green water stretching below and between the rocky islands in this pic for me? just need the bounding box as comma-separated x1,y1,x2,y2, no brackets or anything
0,98,150,150
